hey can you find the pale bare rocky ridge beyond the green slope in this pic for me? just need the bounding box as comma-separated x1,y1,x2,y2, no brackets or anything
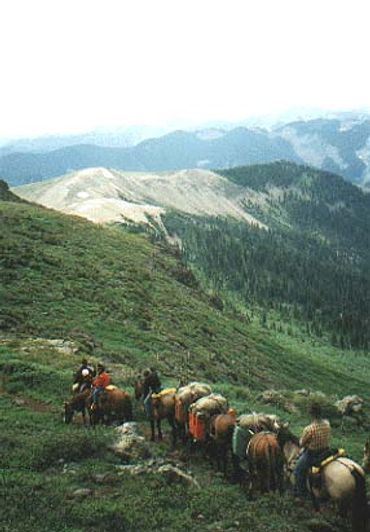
14,168,265,227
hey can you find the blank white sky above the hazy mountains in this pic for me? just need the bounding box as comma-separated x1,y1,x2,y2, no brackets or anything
0,0,370,139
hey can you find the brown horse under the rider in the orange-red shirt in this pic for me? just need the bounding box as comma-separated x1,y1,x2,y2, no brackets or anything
89,387,132,425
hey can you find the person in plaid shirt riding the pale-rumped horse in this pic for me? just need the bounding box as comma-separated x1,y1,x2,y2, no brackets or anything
295,403,331,497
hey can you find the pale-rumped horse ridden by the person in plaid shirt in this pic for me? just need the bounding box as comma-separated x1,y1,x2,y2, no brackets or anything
278,428,368,532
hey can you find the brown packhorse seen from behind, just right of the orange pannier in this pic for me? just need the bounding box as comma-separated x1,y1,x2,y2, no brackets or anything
209,409,236,474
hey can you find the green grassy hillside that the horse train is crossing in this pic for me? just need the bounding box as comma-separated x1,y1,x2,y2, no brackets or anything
0,197,368,532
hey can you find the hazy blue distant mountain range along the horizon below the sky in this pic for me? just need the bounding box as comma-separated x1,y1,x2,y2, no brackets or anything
0,114,370,186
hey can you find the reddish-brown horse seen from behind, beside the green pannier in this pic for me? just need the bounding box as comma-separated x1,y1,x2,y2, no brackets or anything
247,431,284,492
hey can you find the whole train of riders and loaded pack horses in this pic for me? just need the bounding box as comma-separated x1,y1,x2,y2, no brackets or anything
64,359,370,532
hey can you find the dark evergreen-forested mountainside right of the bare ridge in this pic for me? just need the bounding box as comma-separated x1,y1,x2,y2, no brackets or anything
165,163,370,348
